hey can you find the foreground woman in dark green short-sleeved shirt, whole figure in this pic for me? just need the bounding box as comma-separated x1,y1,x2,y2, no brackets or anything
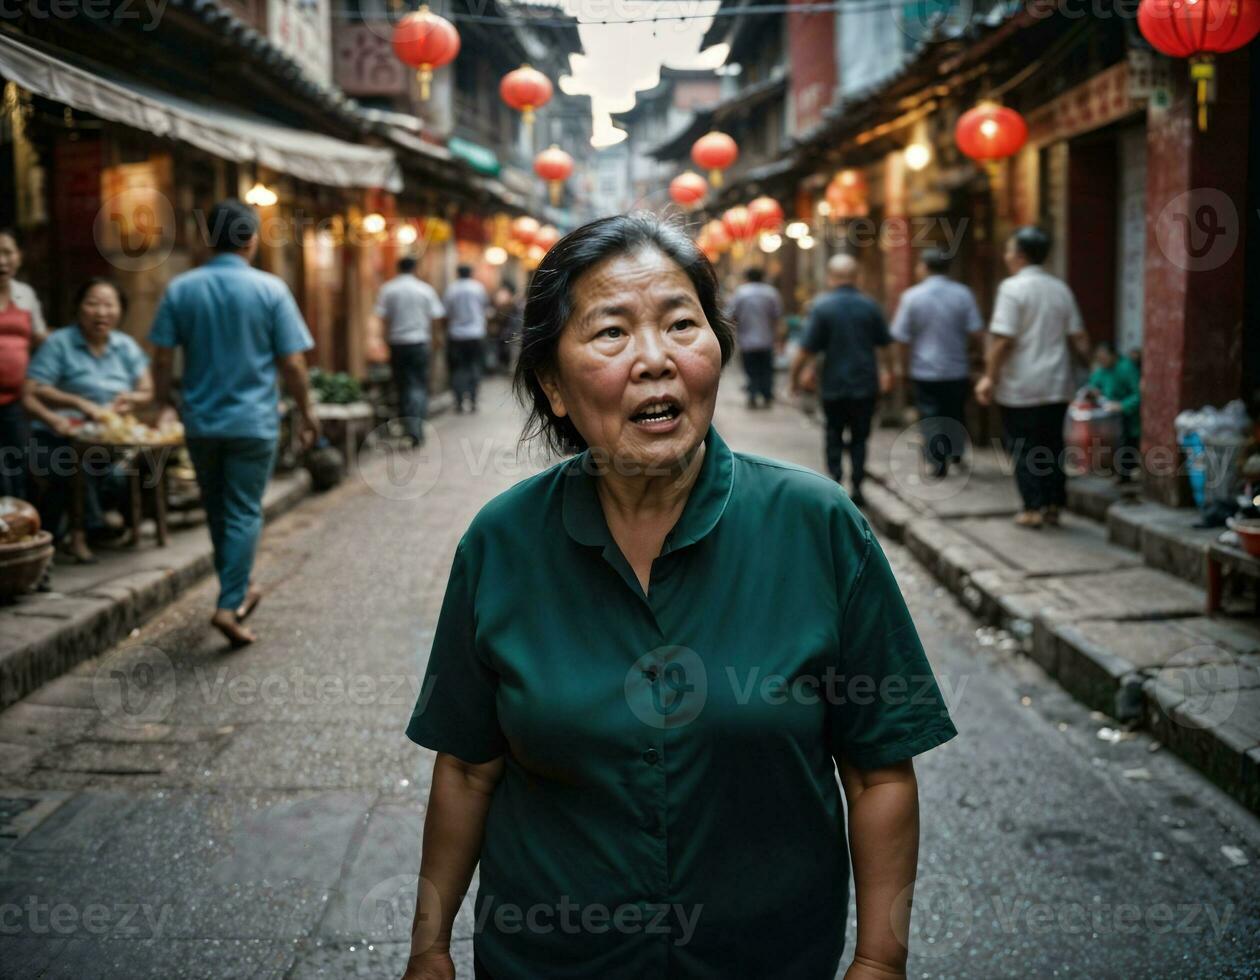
404,214,956,980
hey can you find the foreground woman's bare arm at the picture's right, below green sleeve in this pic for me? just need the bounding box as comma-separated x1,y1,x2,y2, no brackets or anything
839,760,919,980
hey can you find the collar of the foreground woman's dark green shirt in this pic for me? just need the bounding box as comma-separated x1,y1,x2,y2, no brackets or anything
562,424,735,554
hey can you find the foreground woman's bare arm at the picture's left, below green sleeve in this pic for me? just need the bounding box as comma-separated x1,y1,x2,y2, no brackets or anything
403,752,503,980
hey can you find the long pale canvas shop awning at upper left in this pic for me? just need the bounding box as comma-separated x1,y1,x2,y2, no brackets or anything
0,34,402,191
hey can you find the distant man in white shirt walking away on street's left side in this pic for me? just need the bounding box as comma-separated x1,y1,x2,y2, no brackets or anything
373,256,446,446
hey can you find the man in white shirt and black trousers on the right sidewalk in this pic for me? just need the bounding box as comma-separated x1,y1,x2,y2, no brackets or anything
975,225,1090,528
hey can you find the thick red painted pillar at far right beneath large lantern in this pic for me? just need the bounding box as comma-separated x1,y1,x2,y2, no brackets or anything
1142,52,1247,504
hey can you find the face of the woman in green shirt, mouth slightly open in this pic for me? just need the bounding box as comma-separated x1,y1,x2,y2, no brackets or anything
541,248,722,475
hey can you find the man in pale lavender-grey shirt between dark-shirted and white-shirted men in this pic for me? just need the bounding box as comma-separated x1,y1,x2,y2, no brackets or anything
891,248,984,479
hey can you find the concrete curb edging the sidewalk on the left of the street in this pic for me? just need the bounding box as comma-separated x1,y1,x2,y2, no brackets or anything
0,470,310,709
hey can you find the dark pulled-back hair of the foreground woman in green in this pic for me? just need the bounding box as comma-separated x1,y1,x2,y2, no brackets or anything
513,212,735,456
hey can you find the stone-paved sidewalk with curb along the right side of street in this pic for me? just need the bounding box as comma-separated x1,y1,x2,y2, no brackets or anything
864,427,1260,810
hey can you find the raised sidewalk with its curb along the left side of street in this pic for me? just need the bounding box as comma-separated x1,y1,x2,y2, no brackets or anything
0,470,310,708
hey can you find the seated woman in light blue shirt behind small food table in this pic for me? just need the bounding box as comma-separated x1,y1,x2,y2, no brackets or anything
23,277,152,563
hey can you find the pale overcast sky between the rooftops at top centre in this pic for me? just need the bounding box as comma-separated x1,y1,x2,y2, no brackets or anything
514,0,726,146
